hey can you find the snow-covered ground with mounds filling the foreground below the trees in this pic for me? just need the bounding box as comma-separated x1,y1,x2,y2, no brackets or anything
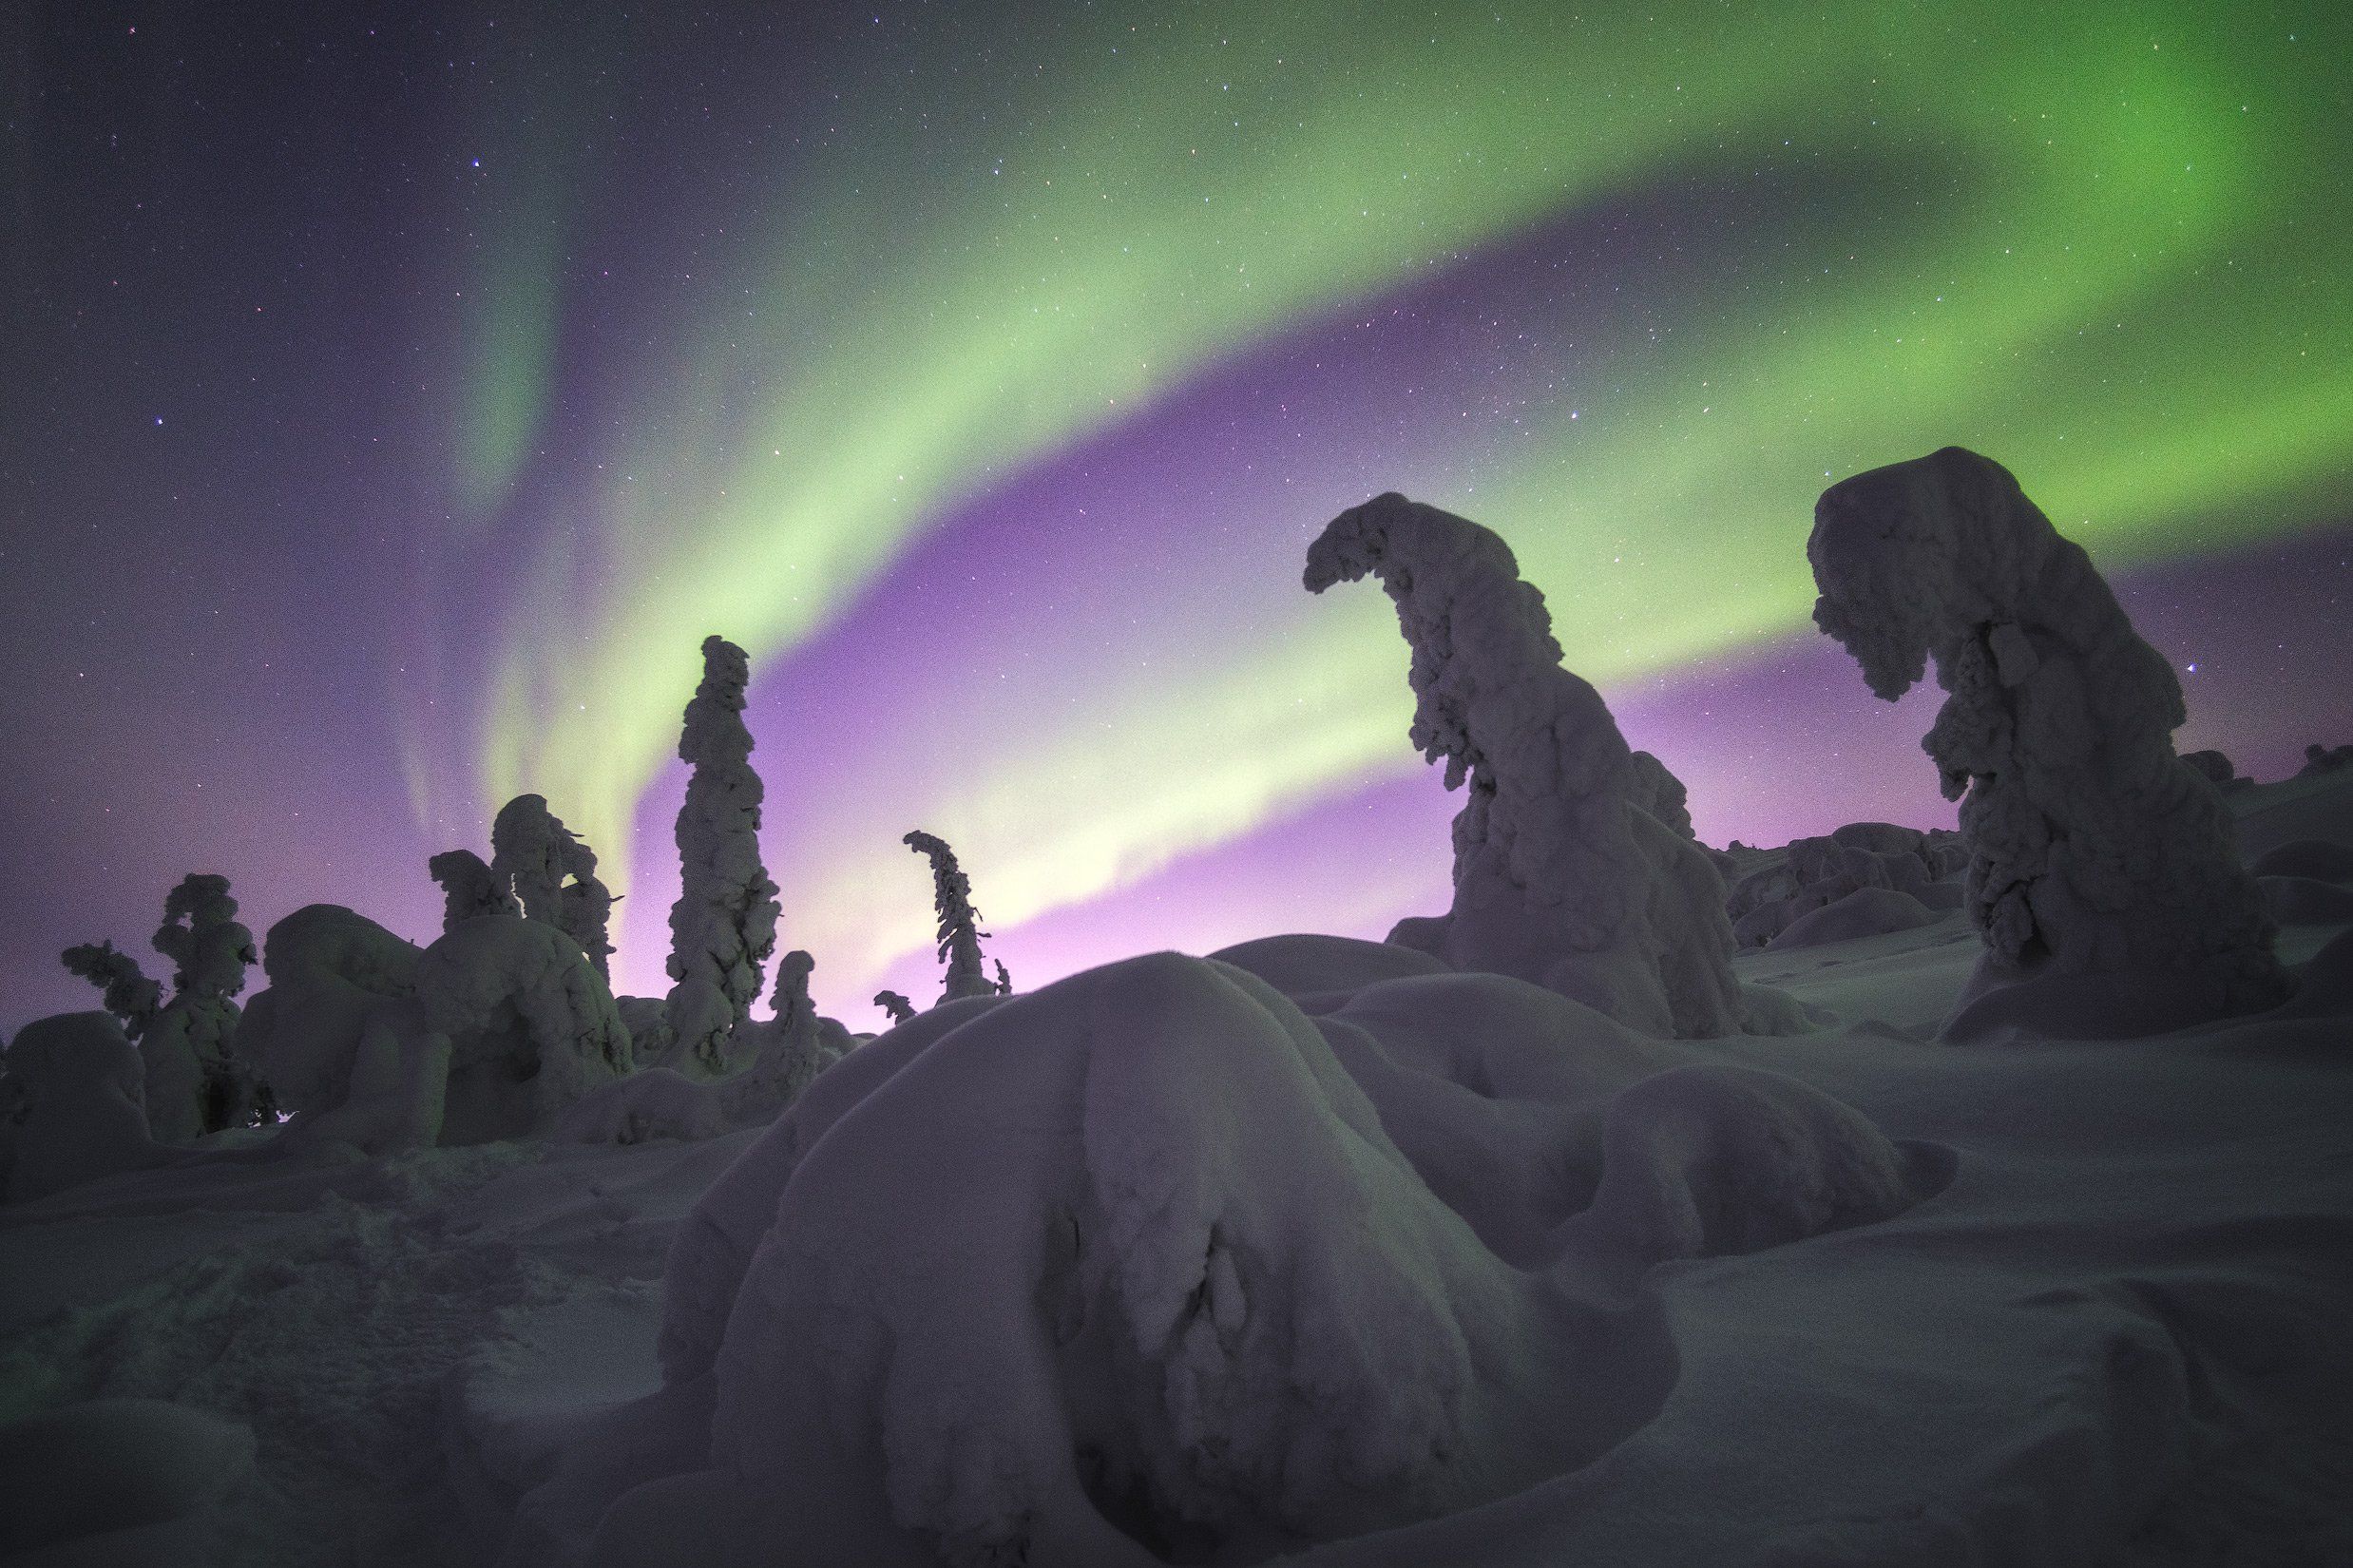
0,770,2353,1568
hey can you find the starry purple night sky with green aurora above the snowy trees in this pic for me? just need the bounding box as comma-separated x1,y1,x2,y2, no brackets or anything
0,0,2353,1029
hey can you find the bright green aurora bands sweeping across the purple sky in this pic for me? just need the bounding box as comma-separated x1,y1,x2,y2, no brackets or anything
442,2,2353,967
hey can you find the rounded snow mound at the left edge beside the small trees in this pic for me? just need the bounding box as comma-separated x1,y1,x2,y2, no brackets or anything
0,1012,169,1203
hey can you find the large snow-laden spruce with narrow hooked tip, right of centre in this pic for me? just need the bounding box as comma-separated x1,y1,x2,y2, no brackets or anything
1306,492,1741,1036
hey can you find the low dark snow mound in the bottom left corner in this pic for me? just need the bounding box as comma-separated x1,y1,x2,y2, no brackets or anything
0,1399,254,1563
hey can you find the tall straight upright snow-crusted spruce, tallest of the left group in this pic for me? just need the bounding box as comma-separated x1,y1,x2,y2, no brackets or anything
663,638,781,1076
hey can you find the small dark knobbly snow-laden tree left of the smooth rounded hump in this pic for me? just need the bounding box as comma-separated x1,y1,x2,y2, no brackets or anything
139,873,261,1142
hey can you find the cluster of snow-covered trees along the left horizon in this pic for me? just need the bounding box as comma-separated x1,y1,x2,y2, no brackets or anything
0,636,1012,1196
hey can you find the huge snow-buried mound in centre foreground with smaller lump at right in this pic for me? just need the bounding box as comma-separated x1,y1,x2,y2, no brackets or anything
539,944,1932,1568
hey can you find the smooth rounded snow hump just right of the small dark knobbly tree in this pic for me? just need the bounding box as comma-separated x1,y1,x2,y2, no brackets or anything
236,904,424,1111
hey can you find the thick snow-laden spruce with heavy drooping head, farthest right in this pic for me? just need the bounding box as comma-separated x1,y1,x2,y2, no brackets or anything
1805,448,2289,1034
